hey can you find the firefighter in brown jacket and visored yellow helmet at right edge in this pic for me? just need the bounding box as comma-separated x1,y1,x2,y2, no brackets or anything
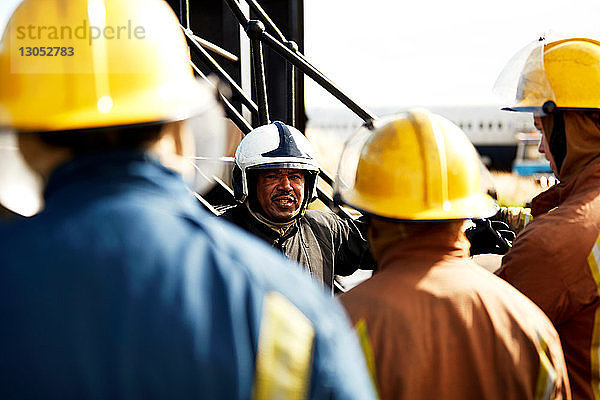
497,38,600,399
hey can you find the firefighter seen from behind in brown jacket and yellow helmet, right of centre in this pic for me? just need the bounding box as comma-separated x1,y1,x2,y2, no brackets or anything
336,109,570,400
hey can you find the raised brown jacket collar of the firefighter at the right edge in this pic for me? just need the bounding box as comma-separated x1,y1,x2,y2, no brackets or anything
531,163,600,217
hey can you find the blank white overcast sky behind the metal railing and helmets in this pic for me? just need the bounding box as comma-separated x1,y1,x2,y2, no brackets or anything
0,0,600,110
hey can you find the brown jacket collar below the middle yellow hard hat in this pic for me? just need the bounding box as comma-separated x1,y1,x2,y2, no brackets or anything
377,226,470,272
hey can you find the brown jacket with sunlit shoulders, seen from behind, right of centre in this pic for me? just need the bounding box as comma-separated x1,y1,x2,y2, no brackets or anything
340,228,570,400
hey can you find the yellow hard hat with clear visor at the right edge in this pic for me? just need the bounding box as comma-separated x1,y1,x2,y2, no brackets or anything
495,38,600,114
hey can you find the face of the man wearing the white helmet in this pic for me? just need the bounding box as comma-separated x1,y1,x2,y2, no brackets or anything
256,169,304,222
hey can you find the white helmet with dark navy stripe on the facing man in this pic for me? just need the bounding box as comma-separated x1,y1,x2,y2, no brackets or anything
232,121,319,207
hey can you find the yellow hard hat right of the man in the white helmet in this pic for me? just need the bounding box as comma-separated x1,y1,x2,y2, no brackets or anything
335,110,496,220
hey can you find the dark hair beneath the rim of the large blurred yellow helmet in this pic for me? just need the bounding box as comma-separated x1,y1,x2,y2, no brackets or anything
21,123,164,155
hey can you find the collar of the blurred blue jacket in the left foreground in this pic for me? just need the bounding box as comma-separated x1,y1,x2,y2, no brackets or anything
44,151,201,219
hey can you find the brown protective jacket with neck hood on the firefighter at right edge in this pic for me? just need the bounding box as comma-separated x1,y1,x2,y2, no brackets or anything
498,113,600,399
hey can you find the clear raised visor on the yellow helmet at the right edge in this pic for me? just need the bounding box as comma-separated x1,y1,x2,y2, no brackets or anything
493,37,556,115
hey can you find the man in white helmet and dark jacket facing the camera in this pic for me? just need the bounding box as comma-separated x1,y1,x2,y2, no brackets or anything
223,122,373,288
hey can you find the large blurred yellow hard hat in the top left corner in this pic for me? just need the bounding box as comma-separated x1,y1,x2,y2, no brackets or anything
0,0,214,131
